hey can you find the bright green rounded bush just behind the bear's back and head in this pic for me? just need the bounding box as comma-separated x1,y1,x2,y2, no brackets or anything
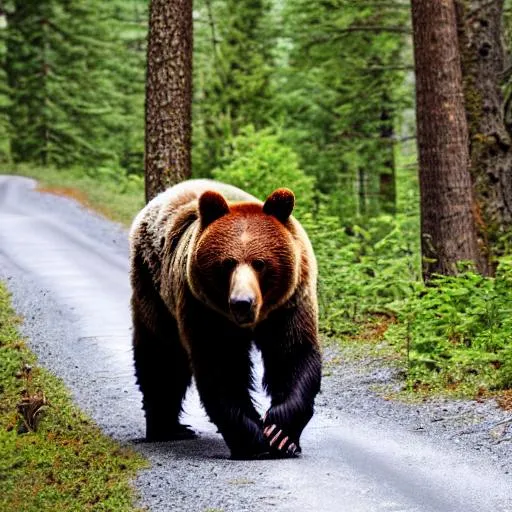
212,126,315,212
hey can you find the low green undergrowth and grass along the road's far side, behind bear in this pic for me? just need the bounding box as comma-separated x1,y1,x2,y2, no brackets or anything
7,127,512,397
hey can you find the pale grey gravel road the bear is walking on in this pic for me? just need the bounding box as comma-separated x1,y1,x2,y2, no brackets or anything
0,176,512,512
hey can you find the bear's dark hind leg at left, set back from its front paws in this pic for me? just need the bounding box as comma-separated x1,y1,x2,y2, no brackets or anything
133,315,196,441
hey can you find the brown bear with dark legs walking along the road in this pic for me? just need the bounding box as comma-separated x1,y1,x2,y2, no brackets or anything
130,180,321,459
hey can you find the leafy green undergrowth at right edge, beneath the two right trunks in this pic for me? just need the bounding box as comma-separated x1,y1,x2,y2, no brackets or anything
388,258,512,391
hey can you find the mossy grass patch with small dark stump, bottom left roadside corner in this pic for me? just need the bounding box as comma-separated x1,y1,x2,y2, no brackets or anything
0,283,146,512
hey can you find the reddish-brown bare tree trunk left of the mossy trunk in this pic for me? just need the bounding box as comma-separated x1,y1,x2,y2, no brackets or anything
412,0,481,279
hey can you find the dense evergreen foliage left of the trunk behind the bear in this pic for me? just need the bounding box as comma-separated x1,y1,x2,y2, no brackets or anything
4,0,144,173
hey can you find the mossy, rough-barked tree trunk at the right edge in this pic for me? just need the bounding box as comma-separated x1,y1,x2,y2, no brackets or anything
456,0,512,264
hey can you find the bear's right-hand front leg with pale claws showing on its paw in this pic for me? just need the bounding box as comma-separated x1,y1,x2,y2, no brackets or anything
255,303,322,456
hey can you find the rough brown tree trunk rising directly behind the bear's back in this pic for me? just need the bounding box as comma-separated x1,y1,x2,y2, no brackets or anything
145,0,192,201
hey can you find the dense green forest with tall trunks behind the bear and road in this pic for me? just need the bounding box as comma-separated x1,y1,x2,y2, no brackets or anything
0,0,512,396
